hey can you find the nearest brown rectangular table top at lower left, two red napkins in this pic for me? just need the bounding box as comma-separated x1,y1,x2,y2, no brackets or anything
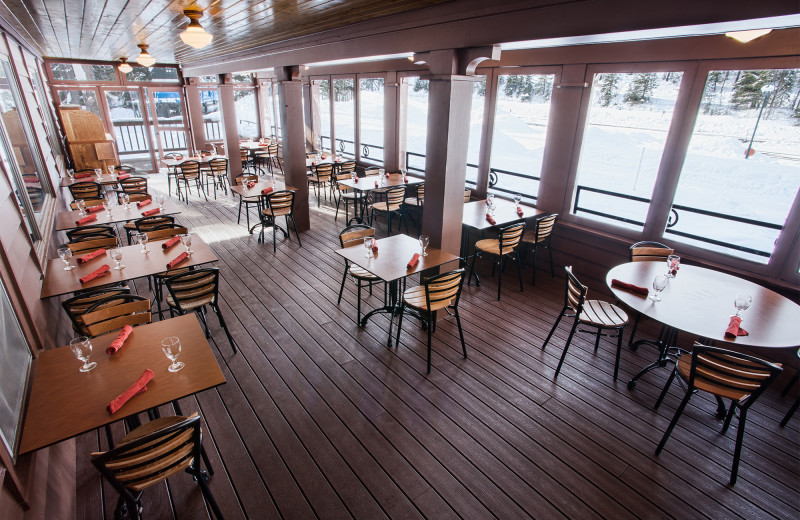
20,313,225,453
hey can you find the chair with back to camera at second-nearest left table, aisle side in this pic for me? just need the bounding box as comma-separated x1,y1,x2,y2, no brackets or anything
164,267,236,354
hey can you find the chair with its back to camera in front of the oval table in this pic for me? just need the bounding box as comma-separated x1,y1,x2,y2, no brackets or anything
655,343,783,485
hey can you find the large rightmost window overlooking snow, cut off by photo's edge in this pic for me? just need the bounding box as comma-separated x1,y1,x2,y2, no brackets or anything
665,69,800,264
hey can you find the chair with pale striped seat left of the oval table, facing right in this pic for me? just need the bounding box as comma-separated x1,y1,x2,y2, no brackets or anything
542,266,628,381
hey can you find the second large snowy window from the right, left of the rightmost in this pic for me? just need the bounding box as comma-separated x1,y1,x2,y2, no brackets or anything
572,70,683,230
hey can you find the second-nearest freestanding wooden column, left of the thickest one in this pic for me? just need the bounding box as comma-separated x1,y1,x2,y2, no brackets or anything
275,66,311,231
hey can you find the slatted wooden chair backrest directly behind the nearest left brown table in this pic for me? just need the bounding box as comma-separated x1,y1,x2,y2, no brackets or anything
80,293,151,336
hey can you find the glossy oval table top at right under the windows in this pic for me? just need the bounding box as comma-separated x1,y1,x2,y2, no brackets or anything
606,262,800,348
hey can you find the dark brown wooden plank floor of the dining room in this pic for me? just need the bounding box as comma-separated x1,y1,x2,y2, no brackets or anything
77,172,800,519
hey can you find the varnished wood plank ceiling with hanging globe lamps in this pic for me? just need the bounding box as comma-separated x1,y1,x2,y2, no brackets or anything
0,0,452,63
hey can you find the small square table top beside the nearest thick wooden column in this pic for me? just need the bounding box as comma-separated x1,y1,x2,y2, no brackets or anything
336,235,460,282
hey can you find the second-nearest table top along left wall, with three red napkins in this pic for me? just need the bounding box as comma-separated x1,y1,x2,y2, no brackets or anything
41,233,217,298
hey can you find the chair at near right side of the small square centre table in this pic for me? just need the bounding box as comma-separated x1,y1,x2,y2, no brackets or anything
390,269,467,374
